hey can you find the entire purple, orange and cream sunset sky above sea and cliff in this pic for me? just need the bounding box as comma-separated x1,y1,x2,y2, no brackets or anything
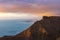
0,0,60,19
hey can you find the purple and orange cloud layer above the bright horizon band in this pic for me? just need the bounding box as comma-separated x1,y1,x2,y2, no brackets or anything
0,0,60,15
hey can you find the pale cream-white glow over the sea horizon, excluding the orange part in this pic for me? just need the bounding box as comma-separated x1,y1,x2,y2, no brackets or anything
0,12,39,20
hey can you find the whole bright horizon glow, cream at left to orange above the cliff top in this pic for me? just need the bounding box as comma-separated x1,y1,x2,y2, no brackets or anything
0,12,57,20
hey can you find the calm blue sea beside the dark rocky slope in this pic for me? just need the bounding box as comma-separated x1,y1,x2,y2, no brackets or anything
0,20,34,37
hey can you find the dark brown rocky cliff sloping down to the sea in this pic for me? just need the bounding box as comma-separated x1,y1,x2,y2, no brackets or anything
0,16,60,40
